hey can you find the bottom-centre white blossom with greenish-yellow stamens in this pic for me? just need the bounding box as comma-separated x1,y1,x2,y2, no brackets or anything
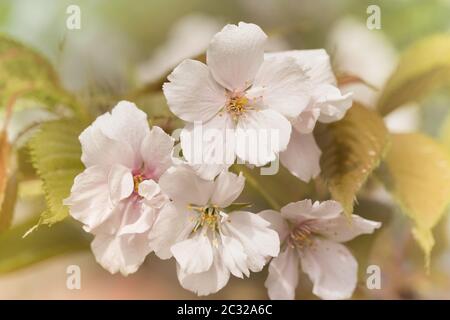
150,166,280,295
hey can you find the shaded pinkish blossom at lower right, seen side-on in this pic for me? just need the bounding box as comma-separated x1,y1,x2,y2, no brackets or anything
259,200,381,299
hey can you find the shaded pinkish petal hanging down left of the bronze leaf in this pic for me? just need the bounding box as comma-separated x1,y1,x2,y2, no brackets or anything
280,130,322,182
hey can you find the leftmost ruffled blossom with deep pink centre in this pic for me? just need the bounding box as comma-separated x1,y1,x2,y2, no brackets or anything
64,101,173,275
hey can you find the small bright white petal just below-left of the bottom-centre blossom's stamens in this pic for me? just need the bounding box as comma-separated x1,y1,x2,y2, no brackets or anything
171,231,213,274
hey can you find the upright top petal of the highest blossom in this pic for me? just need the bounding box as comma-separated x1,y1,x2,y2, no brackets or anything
206,22,267,91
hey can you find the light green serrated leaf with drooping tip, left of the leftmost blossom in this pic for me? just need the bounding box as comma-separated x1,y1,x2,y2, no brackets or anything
29,120,84,225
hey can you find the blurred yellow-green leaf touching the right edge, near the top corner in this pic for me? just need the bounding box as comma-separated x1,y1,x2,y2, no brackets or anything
378,34,450,115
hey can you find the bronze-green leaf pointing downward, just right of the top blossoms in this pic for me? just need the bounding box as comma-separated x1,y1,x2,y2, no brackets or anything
315,104,389,215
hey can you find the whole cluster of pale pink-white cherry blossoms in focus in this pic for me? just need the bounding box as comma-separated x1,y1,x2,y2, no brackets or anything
64,22,380,299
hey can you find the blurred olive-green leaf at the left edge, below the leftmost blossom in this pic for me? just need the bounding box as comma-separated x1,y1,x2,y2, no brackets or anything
0,218,89,274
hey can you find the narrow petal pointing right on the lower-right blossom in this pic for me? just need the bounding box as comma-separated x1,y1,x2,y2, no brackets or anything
311,215,381,242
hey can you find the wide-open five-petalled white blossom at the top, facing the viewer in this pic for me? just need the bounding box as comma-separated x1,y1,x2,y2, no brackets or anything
163,22,311,179
